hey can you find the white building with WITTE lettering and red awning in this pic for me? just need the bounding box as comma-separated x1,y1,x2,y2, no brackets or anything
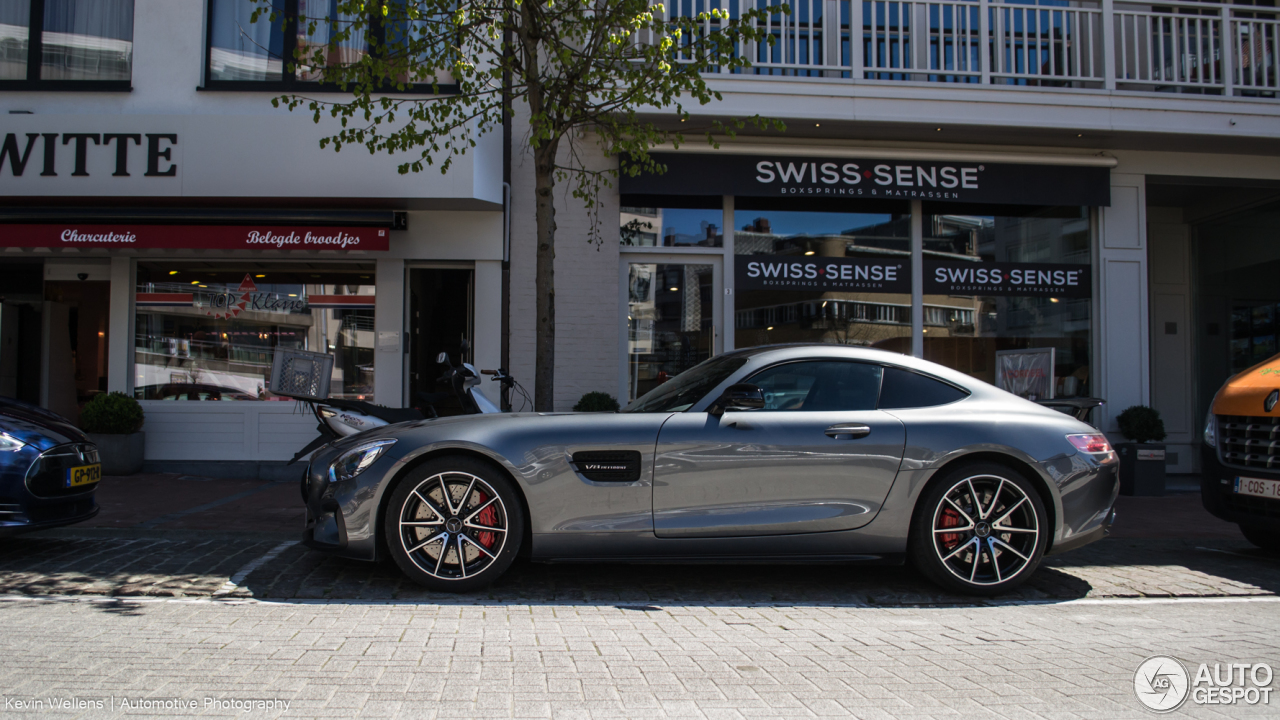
0,0,504,475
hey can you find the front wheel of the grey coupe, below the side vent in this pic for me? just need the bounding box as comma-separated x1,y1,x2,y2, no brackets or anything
384,457,525,592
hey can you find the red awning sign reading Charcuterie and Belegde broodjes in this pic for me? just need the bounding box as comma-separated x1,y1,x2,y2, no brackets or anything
0,224,389,252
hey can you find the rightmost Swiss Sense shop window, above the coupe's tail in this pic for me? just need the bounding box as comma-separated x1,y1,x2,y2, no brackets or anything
924,204,1093,400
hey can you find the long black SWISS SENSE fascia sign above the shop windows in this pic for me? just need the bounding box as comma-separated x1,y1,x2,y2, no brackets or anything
620,152,1111,206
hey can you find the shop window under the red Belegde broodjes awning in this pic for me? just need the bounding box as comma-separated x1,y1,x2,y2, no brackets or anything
133,260,374,401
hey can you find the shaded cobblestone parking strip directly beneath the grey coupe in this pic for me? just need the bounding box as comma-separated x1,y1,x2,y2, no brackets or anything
0,529,1280,606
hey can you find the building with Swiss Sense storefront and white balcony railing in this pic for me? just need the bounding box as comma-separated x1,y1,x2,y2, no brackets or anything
511,0,1280,473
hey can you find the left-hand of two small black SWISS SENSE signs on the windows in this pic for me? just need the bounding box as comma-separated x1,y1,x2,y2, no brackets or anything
733,255,911,293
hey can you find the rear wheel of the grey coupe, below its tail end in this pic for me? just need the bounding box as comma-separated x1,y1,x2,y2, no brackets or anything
910,462,1051,596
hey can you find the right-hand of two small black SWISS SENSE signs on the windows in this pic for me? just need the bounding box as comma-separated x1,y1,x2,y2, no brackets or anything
924,259,1093,297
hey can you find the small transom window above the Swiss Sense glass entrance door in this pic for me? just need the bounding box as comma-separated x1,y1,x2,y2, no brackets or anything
618,195,724,247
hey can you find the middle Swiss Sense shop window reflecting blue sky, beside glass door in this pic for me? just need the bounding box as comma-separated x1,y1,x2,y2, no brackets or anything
733,197,911,352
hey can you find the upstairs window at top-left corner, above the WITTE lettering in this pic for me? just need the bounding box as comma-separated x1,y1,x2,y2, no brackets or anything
0,0,133,90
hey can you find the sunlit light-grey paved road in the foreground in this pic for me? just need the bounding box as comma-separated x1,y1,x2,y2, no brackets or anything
0,597,1280,720
